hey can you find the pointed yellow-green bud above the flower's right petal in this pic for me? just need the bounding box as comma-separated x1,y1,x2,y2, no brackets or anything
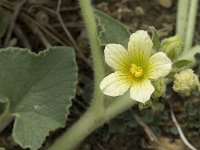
161,35,182,60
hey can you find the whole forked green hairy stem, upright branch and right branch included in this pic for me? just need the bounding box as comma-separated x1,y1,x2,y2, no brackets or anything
49,0,136,150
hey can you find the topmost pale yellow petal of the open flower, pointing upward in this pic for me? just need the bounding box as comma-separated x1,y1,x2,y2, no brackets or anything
128,30,153,63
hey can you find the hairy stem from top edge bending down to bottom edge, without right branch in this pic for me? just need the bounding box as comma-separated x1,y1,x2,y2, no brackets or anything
50,0,105,150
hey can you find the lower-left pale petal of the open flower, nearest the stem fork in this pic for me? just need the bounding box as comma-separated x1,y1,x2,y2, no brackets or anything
100,71,130,96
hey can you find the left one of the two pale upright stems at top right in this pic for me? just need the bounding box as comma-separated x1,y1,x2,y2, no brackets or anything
176,0,190,41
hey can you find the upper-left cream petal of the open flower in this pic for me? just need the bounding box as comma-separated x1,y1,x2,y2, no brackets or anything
104,44,130,70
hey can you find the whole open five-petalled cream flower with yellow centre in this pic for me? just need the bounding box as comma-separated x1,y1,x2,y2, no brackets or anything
100,30,172,103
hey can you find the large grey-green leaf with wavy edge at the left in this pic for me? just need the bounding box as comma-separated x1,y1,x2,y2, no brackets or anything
0,47,77,150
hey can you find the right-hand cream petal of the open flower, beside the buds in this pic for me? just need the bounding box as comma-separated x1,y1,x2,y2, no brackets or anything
148,52,172,80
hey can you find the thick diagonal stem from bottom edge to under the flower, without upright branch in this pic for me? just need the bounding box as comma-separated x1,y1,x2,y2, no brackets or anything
49,94,137,150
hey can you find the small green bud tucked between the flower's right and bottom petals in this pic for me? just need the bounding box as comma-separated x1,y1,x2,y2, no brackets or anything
152,78,167,98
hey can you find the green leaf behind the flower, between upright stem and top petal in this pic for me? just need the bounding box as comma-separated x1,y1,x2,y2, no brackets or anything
95,10,130,47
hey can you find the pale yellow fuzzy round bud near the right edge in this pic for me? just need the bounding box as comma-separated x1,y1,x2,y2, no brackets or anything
173,69,200,96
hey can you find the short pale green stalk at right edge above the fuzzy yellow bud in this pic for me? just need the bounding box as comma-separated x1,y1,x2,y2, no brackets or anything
178,45,200,62
